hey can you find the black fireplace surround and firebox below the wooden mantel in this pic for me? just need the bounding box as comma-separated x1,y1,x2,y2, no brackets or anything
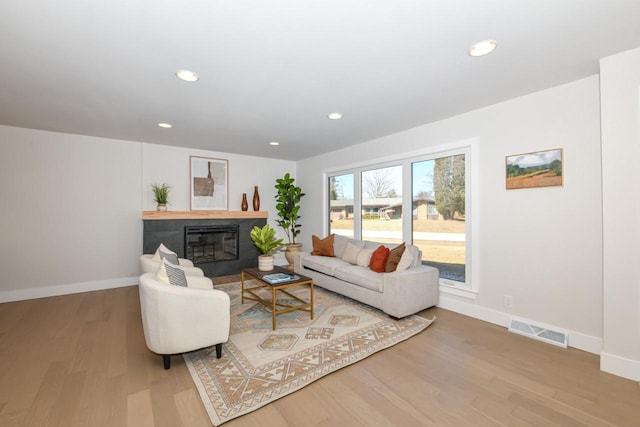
143,218,267,277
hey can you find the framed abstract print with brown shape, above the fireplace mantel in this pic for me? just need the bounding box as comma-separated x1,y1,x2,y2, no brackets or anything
189,156,229,211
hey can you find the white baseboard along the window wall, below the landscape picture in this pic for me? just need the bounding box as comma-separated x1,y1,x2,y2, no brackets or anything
438,292,602,355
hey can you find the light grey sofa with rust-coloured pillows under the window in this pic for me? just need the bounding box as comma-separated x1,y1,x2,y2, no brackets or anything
294,235,439,318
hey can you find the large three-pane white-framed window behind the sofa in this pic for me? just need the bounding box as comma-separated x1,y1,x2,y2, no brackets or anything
327,145,477,297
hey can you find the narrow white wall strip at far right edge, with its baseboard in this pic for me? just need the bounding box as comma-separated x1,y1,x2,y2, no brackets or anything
600,49,640,380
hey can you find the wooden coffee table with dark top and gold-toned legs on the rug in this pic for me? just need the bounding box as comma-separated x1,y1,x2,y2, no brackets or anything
242,266,313,331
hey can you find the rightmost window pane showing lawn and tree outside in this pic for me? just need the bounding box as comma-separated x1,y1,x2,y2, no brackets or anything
411,154,466,282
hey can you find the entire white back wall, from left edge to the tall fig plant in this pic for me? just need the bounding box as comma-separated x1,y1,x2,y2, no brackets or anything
0,126,296,302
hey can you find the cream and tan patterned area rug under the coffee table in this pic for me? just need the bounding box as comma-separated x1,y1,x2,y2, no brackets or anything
184,283,435,426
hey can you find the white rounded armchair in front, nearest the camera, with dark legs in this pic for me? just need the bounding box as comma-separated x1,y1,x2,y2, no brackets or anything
139,273,230,369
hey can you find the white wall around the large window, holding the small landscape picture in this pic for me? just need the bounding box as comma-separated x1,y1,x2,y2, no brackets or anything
298,76,602,352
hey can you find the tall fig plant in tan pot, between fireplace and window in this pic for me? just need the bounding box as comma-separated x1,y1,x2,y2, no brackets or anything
275,172,304,265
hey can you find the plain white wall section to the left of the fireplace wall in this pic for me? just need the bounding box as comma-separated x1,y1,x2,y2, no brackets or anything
0,126,142,301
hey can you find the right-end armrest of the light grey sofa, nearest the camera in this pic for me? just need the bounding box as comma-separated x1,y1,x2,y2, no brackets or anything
382,265,440,317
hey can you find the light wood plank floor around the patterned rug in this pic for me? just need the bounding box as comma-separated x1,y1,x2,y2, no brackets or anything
0,277,640,427
